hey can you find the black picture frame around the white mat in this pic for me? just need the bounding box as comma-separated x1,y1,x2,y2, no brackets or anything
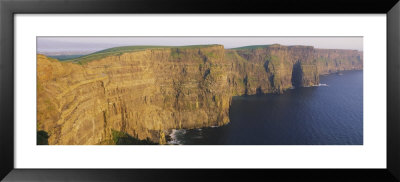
0,0,400,181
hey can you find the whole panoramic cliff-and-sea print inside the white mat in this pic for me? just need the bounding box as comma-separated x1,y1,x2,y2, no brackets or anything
36,36,363,145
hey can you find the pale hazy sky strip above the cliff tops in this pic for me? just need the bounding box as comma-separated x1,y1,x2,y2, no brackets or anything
37,36,363,55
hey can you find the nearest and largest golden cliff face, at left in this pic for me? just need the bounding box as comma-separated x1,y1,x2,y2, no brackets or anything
38,46,231,144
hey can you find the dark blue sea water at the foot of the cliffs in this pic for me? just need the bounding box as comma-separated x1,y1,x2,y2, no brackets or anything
170,71,363,145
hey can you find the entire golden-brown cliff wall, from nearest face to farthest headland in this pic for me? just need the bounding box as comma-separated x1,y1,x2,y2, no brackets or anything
37,45,362,144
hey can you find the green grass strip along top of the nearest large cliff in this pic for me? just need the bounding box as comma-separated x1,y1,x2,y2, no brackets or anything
64,44,220,65
